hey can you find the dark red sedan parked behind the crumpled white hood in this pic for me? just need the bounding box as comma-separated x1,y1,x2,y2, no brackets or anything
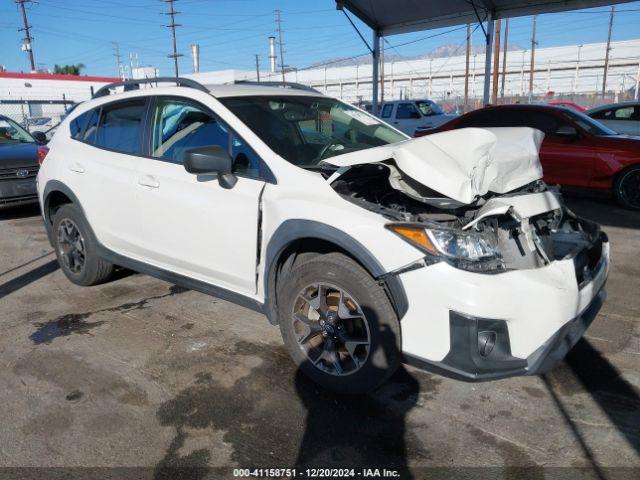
415,105,640,210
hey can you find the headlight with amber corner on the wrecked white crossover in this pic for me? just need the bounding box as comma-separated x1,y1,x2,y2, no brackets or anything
386,223,504,272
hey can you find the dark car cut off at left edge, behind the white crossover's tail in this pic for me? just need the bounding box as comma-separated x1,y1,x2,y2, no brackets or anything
0,115,47,208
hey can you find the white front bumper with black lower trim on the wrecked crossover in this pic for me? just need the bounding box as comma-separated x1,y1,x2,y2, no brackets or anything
401,240,609,381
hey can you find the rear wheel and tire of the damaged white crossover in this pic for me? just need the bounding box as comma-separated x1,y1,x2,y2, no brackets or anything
52,204,114,287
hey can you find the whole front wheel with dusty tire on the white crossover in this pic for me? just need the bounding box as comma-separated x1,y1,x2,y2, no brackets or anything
278,253,401,394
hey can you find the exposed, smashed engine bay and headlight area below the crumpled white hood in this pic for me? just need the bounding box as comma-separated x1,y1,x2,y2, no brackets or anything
329,150,603,278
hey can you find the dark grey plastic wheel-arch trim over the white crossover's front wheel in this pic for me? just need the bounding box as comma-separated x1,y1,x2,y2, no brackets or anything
263,219,409,324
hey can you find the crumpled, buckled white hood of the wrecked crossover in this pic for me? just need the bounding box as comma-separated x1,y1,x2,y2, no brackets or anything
325,127,544,204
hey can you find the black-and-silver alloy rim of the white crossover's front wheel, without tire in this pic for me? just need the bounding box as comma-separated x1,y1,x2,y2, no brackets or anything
292,283,371,376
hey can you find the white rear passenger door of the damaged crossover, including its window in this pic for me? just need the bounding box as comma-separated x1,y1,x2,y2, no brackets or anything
66,98,147,256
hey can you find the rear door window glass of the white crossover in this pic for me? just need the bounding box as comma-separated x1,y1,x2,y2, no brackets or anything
94,99,145,155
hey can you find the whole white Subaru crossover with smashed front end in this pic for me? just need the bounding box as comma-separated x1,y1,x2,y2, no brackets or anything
38,79,609,393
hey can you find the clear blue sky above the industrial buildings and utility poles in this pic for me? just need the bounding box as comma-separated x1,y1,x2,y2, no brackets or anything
0,0,640,76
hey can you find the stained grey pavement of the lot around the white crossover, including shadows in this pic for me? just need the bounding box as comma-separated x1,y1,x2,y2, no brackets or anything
0,197,640,479
